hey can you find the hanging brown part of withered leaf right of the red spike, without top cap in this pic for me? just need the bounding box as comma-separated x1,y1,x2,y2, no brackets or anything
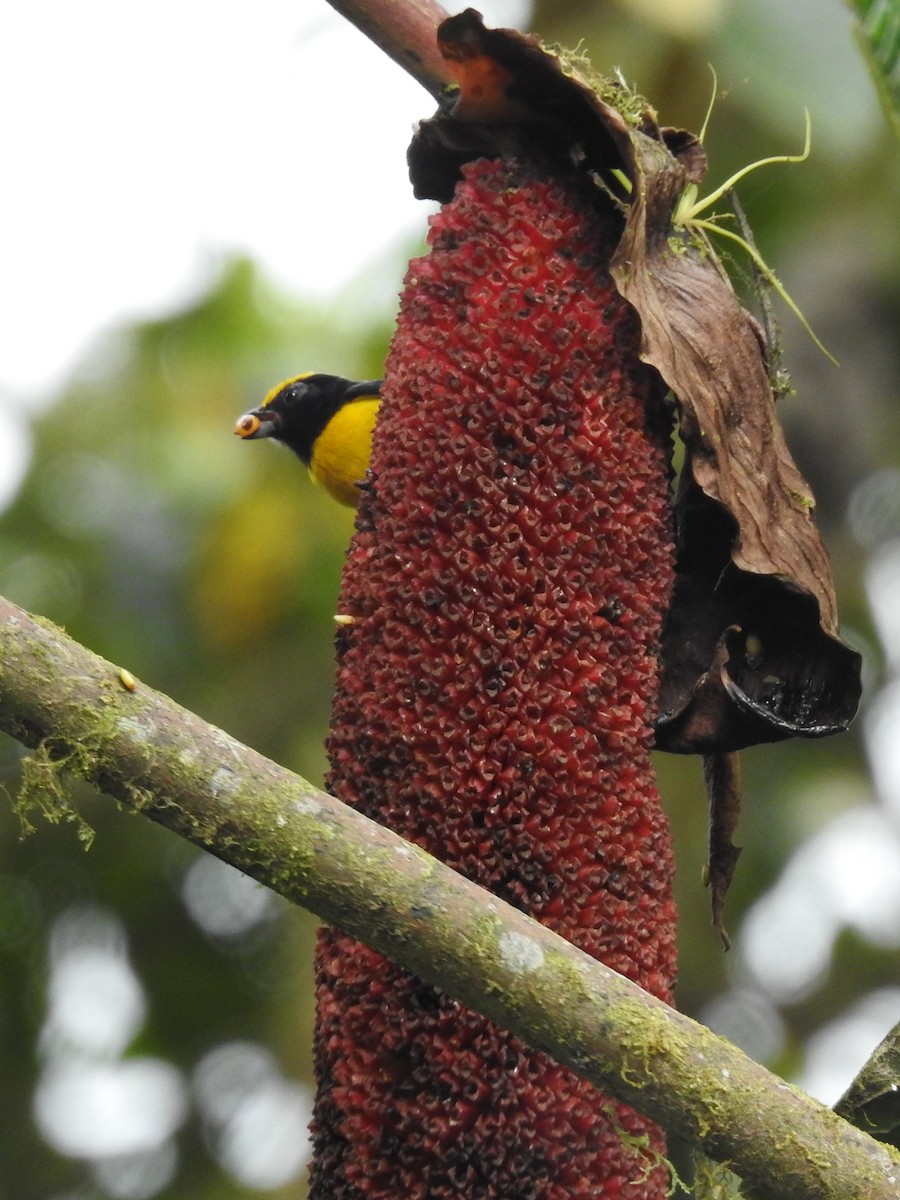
612,133,860,751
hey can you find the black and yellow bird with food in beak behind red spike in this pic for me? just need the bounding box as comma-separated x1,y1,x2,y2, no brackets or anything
234,373,384,508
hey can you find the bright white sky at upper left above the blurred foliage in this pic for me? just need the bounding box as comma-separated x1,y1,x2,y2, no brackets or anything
0,0,529,406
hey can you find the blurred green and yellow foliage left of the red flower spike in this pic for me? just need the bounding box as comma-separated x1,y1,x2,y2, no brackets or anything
0,260,401,1198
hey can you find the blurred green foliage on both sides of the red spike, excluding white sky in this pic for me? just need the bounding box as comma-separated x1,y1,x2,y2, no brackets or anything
0,0,900,1200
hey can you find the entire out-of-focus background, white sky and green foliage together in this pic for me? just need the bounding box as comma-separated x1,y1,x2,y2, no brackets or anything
0,0,900,1200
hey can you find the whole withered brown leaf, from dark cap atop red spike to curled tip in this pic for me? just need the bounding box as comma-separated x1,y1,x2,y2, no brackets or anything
409,8,860,753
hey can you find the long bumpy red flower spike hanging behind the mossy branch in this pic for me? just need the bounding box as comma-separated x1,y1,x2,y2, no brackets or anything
312,161,674,1200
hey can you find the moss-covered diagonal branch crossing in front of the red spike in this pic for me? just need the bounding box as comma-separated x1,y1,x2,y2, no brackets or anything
0,599,900,1200
